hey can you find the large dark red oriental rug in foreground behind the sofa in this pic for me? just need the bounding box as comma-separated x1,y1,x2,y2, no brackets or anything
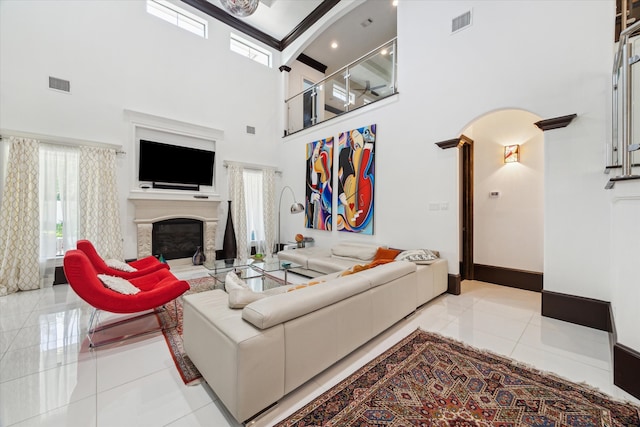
276,329,640,427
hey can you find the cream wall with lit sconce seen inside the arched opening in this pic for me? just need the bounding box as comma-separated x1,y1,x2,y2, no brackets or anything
463,110,544,272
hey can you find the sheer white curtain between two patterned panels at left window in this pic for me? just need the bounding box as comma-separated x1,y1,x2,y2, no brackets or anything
39,144,79,284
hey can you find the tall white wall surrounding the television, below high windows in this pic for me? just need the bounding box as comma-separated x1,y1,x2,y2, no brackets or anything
0,1,282,257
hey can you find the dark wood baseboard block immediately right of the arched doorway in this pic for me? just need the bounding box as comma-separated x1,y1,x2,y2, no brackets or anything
542,290,613,332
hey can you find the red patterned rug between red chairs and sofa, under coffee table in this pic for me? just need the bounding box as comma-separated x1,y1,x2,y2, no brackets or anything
157,276,215,385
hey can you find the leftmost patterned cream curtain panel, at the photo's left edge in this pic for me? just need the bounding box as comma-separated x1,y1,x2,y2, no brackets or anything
0,137,40,295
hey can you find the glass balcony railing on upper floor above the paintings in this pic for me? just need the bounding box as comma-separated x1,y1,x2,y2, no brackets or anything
285,38,398,135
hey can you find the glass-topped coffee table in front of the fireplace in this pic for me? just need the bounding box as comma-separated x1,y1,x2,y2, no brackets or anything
204,258,302,292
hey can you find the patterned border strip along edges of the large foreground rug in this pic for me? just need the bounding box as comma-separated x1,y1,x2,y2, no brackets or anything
274,328,640,427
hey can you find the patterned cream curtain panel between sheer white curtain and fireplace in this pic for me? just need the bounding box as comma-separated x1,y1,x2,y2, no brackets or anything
79,147,123,259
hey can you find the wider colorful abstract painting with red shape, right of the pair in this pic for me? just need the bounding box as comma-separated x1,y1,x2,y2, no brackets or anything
336,125,376,234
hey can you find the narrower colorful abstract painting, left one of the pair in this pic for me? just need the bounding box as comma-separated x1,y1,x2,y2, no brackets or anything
305,137,333,230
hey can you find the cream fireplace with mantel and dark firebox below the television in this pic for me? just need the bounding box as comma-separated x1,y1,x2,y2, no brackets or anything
129,195,220,262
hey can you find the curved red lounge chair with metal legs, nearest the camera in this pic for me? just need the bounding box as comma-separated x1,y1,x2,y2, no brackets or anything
63,249,189,347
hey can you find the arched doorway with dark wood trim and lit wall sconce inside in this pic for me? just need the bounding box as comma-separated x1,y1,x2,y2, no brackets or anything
458,109,544,290
